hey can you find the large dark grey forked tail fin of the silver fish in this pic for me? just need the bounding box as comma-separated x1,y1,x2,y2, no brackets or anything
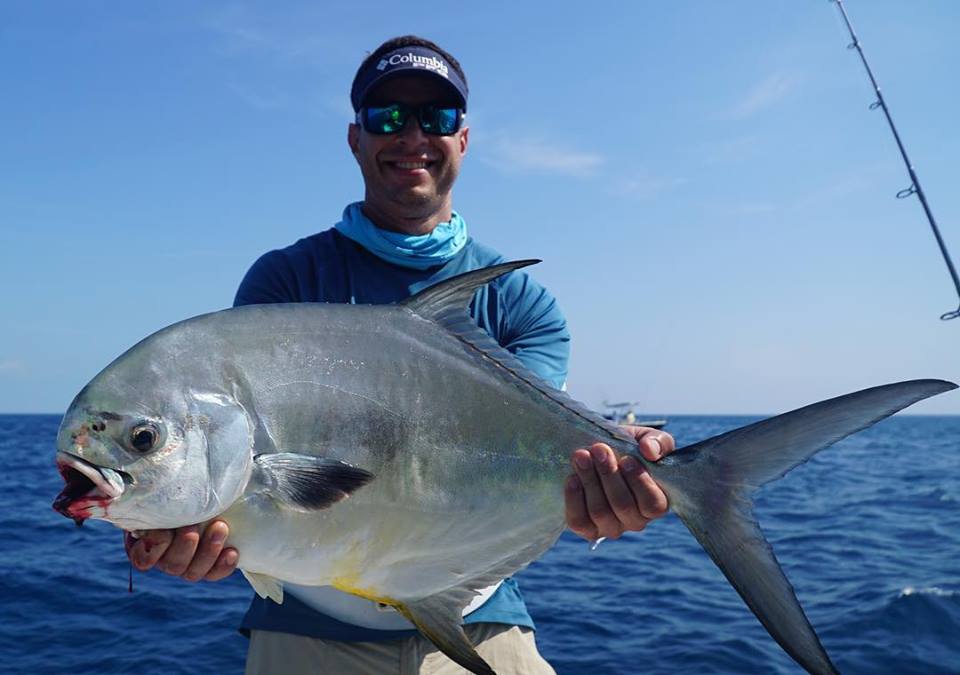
652,380,957,673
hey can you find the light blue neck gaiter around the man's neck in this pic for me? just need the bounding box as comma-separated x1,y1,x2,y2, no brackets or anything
335,202,467,270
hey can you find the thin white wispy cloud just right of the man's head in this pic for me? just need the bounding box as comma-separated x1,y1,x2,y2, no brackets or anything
482,133,604,177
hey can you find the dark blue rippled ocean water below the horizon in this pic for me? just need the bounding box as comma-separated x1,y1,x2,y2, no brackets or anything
0,415,960,675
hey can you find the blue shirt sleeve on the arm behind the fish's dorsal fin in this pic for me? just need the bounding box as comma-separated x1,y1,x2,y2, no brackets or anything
501,274,570,389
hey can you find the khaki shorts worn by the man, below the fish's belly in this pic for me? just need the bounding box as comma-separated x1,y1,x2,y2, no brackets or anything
246,623,556,675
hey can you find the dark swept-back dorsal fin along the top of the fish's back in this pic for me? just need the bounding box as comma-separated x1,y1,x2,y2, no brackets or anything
400,259,636,444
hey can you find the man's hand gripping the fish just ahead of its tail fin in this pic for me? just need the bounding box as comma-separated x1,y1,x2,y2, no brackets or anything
564,427,674,541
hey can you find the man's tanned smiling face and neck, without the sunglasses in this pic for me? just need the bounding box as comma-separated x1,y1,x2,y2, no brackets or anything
348,75,468,233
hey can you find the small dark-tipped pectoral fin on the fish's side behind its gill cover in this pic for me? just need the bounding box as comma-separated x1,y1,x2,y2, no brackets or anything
253,452,373,511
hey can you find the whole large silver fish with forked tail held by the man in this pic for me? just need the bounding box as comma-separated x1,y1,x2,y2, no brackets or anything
54,261,956,673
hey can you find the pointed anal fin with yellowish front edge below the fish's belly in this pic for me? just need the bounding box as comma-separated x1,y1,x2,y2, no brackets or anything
397,590,496,675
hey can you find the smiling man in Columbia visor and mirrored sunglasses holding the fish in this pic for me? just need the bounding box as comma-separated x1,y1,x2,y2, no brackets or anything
128,36,673,675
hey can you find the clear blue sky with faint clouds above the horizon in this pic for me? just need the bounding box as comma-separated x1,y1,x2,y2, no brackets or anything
0,0,960,415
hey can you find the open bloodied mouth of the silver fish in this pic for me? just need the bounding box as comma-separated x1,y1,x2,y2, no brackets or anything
53,452,133,525
